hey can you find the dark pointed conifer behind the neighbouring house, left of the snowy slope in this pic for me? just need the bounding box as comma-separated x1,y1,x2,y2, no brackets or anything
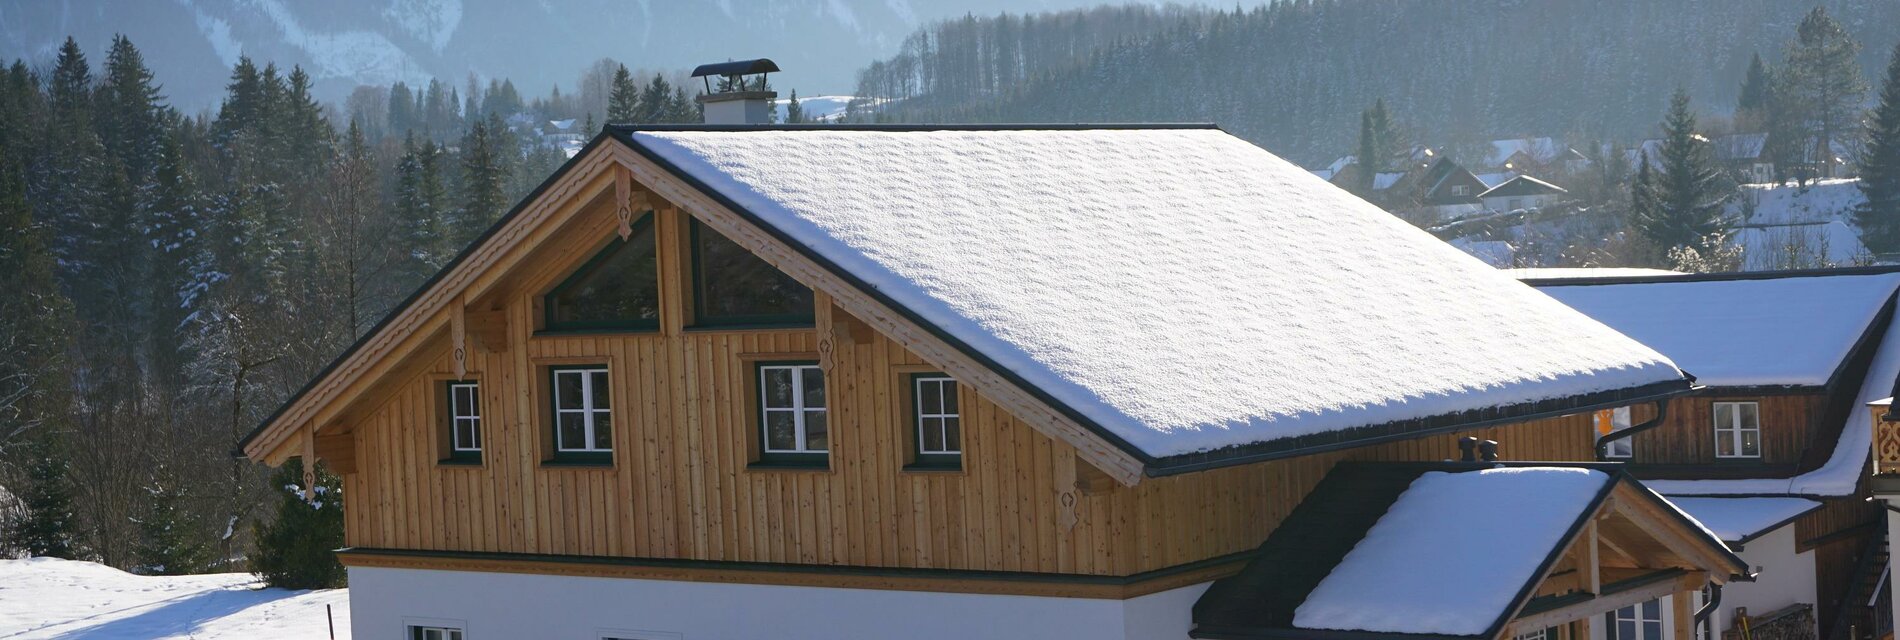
1632,89,1733,249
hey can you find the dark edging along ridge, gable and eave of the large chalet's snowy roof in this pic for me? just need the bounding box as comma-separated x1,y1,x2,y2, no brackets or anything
606,123,1689,477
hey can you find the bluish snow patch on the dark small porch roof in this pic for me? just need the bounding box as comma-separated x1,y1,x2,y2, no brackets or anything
1294,467,1611,636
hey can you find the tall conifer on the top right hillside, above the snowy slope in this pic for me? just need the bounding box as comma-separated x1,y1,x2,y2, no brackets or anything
1777,6,1868,175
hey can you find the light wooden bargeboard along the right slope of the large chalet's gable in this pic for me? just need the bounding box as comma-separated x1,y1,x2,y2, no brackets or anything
608,144,1144,486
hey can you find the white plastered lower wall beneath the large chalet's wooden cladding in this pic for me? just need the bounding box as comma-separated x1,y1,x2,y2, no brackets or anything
350,568,1208,640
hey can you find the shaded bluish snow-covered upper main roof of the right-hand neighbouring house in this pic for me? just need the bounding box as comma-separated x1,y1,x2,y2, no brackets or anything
1541,273,1900,387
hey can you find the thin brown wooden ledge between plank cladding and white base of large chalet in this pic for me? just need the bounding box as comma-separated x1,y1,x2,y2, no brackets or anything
336,547,1258,587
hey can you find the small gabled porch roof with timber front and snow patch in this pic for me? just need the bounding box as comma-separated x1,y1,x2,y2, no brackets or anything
1193,463,1748,638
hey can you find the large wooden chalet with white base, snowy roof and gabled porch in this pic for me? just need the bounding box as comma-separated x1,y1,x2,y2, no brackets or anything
243,62,1750,640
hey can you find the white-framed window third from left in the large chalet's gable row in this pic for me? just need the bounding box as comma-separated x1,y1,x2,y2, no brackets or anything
758,363,830,465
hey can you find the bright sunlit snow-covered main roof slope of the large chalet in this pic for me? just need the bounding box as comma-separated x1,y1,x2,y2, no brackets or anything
614,125,1682,458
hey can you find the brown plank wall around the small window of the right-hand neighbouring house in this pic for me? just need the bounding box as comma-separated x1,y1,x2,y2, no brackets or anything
1632,391,1828,465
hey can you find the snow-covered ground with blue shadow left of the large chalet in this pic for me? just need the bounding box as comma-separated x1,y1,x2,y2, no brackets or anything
0,558,350,640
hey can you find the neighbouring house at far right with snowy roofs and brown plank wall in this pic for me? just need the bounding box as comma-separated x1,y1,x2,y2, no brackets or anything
1531,268,1900,638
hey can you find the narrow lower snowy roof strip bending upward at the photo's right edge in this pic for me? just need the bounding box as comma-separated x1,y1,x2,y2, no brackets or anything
1645,286,1900,496
